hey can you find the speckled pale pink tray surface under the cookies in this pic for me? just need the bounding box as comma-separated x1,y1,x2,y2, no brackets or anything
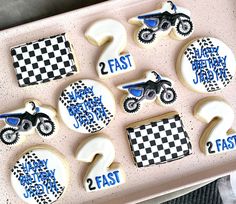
0,0,236,204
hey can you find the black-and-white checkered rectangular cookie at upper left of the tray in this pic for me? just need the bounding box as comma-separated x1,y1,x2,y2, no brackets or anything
11,34,77,87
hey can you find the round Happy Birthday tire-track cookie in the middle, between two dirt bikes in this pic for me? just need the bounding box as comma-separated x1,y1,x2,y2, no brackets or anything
58,79,116,133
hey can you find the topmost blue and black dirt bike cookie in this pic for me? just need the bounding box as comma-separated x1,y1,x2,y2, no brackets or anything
129,1,193,48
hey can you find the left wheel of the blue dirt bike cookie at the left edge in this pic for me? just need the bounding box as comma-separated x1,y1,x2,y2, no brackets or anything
0,128,19,145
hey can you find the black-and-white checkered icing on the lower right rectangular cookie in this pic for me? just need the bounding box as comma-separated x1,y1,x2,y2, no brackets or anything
127,115,192,167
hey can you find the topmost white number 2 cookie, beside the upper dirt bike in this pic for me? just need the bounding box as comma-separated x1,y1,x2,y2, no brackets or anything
85,19,135,78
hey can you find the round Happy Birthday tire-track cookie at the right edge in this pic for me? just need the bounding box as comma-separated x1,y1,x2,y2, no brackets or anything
176,37,236,93
